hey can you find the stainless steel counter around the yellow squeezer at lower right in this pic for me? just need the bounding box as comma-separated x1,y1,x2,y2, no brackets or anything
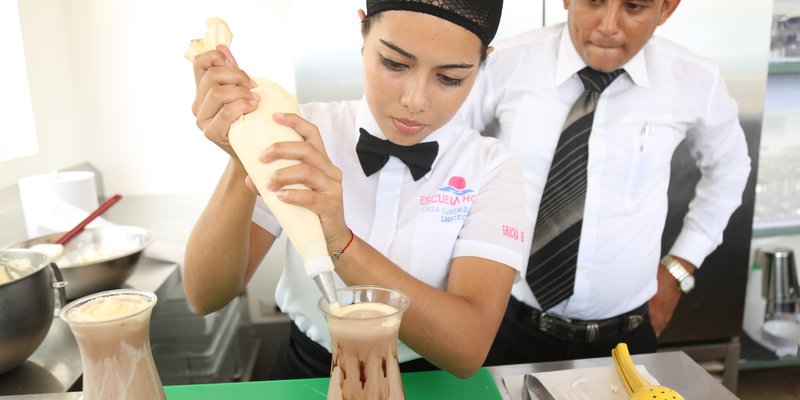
489,352,738,400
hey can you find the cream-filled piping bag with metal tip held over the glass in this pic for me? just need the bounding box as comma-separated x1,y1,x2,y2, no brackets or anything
184,18,338,309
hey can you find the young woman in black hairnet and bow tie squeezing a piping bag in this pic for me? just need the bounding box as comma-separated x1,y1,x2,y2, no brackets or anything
184,0,533,379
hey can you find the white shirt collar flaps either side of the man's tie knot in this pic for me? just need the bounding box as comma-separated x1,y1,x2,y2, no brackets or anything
555,24,652,88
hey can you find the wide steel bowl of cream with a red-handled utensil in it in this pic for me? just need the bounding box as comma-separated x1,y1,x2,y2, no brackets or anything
8,225,154,300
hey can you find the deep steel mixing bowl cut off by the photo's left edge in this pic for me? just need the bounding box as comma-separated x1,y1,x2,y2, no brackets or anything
0,249,65,374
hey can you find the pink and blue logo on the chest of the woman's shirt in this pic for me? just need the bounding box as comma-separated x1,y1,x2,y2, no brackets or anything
419,176,478,223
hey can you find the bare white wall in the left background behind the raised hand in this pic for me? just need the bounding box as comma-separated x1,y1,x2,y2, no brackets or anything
0,0,294,195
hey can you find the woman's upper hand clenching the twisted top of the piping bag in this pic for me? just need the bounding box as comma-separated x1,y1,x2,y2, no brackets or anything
192,45,259,158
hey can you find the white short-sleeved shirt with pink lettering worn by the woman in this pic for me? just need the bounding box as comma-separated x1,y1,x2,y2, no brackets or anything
253,99,534,362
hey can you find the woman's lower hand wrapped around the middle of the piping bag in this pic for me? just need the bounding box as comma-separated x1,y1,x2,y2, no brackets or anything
259,113,350,251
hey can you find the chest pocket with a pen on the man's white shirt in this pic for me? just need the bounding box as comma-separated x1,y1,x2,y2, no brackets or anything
625,121,684,212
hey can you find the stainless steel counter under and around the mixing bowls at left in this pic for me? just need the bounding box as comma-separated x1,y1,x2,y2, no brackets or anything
0,195,205,398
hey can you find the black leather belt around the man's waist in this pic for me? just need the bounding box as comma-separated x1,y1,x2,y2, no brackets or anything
508,296,647,343
